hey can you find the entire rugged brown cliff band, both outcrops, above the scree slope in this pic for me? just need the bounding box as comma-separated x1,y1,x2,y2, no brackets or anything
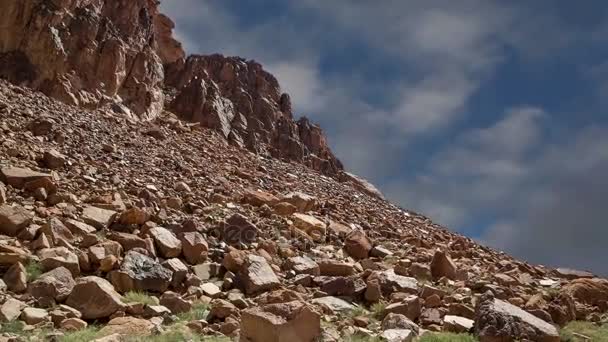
0,0,342,176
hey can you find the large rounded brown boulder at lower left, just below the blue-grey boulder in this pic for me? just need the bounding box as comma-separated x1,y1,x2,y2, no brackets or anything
66,276,126,319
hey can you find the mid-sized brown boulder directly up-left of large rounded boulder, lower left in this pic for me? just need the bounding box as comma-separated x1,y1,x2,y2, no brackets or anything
28,267,76,302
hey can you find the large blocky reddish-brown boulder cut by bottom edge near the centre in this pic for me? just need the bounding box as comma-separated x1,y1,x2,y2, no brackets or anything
240,301,321,342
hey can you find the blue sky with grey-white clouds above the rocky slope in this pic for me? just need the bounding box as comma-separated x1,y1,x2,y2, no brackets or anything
162,0,608,274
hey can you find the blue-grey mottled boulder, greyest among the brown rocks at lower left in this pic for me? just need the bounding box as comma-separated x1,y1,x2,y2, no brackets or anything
110,250,173,292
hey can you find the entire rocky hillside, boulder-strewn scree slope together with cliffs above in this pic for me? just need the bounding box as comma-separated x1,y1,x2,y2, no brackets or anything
0,0,608,342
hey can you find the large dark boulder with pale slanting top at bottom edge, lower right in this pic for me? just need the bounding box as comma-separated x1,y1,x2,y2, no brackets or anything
475,292,560,342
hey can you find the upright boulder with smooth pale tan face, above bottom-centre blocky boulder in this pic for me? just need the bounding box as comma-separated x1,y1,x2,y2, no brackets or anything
238,255,281,294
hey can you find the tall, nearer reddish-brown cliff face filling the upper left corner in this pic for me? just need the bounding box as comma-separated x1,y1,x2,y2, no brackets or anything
0,0,164,119
